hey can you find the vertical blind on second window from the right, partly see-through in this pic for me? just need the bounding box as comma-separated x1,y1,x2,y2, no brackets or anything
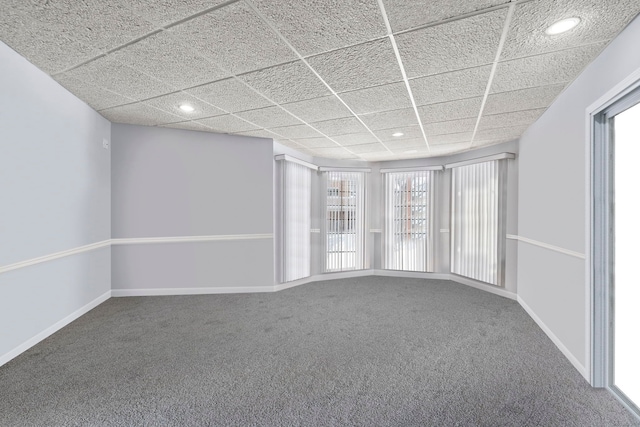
384,171,434,272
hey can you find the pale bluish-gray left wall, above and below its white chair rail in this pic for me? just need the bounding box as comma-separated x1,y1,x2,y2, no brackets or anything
0,43,111,357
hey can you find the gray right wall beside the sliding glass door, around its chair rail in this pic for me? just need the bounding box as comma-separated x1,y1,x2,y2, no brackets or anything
518,13,640,374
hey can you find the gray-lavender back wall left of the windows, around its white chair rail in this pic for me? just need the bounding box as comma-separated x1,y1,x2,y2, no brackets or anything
112,124,274,290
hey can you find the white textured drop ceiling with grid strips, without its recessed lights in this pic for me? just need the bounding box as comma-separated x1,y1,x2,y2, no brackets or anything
0,0,640,161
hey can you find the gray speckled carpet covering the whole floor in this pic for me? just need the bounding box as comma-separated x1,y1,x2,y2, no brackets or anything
0,277,640,427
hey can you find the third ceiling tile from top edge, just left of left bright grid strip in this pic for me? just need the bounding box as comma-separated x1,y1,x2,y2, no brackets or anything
340,82,411,114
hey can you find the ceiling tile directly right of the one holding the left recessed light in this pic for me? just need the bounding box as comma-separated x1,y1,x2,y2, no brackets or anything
186,78,273,113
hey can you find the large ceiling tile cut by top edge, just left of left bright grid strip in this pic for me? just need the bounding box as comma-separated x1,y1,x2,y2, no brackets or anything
253,0,386,56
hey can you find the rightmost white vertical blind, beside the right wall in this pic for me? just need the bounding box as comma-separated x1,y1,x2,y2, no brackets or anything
451,160,506,286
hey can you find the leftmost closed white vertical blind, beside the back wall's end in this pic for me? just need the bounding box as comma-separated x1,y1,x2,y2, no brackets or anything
280,161,311,282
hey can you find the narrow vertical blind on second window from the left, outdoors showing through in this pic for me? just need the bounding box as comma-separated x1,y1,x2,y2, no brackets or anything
323,171,366,272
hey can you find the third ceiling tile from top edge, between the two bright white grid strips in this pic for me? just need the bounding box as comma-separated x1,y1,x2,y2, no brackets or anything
409,65,491,105
